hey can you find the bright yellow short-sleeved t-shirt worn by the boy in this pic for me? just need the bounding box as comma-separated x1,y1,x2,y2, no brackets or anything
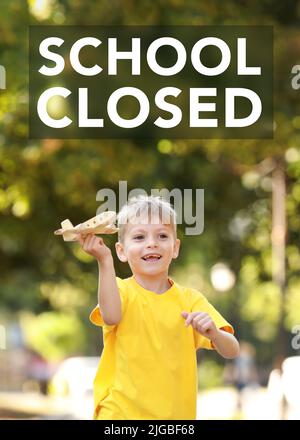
90,276,233,420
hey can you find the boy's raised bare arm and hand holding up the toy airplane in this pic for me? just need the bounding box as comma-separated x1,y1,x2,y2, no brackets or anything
78,234,122,325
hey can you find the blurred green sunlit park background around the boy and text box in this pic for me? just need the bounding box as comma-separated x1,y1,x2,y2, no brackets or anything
0,0,300,419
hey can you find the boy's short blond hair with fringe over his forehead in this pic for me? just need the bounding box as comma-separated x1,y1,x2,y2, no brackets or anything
117,195,176,242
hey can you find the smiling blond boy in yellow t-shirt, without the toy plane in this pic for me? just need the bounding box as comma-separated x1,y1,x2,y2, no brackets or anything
79,196,239,420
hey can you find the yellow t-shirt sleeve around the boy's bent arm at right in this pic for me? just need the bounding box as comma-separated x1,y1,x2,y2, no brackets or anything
191,290,234,350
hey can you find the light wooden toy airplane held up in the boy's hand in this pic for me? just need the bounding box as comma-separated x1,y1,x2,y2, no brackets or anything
54,211,118,241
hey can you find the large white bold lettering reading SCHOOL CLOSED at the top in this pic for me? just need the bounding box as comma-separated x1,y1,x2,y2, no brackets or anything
37,36,262,129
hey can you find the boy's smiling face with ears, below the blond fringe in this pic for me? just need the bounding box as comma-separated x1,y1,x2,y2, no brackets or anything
116,217,180,275
